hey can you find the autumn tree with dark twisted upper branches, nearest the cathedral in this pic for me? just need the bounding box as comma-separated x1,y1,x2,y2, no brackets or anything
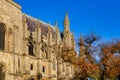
61,34,99,80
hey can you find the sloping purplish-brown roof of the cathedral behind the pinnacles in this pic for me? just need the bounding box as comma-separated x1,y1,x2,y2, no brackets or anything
23,14,55,37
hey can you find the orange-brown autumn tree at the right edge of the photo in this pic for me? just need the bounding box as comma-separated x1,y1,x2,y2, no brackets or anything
100,41,120,80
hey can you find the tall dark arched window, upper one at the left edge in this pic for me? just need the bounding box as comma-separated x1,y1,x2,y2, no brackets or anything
0,23,5,50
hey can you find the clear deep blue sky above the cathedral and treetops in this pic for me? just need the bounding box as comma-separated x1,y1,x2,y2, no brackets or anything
15,0,120,40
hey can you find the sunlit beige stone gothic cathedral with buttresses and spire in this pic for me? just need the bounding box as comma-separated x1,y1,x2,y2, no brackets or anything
0,0,75,80
